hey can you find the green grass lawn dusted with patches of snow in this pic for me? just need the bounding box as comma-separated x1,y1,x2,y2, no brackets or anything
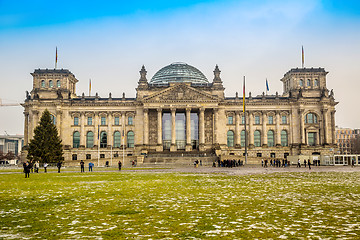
0,171,360,239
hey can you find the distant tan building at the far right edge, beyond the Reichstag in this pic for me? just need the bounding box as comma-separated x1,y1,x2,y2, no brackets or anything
336,127,360,154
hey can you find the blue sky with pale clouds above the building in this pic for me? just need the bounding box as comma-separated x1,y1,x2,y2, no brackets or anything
0,0,360,135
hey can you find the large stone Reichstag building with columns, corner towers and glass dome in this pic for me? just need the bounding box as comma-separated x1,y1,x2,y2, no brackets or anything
23,63,337,163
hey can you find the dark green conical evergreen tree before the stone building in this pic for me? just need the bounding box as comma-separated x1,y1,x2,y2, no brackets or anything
27,109,64,163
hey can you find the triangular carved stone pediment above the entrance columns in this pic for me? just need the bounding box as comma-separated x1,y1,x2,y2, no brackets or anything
144,84,219,102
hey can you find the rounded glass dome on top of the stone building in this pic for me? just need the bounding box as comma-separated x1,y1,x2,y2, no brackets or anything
150,62,209,85
